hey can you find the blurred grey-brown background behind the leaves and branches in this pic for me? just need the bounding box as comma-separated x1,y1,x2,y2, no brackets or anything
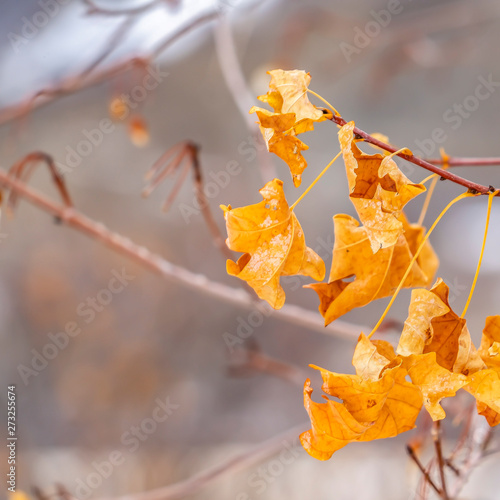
0,0,500,500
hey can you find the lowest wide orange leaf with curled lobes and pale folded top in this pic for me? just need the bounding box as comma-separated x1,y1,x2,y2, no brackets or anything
300,334,422,460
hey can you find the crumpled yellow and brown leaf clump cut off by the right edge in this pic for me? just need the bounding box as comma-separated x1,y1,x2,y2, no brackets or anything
397,279,500,425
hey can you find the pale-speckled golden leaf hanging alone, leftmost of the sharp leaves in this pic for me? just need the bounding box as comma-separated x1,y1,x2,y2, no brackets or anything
221,179,325,309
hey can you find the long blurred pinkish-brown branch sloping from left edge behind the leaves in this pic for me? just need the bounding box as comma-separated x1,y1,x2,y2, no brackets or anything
0,165,362,340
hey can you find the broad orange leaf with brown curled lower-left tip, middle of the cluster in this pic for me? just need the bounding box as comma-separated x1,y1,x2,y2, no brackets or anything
307,215,439,325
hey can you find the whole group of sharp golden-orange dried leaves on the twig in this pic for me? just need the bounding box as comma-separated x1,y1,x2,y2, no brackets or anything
222,70,500,460
